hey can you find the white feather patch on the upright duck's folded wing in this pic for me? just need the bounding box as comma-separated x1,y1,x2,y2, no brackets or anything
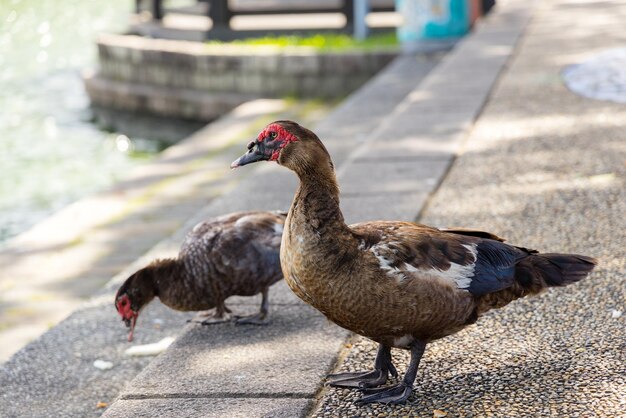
370,242,477,289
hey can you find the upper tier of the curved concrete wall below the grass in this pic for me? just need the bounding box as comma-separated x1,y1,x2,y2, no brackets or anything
92,34,398,98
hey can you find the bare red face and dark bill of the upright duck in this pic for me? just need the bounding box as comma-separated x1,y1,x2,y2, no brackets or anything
230,123,298,168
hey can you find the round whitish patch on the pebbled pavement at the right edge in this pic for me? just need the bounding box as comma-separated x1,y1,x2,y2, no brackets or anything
561,48,626,103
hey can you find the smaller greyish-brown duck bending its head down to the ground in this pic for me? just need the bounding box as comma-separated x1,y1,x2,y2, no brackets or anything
115,212,287,341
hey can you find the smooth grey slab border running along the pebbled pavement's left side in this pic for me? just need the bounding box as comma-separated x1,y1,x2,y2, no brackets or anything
105,4,528,417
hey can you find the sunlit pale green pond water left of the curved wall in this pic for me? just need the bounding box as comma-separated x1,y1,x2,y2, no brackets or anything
0,0,163,246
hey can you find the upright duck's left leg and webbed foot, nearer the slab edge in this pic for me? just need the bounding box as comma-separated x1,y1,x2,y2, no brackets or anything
326,344,398,389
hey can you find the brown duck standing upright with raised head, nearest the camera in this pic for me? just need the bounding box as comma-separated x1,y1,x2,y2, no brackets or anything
231,121,596,403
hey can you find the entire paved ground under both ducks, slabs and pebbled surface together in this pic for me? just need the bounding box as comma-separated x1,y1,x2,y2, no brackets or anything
0,0,626,417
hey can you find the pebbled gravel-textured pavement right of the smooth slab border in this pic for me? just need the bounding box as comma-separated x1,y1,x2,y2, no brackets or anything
312,0,626,417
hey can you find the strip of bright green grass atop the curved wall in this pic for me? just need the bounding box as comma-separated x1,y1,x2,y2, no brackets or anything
207,32,398,51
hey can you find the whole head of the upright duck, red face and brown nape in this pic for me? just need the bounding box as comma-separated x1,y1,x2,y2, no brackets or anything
230,120,333,173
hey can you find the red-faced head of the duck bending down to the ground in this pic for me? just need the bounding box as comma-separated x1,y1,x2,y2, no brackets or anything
115,267,155,341
